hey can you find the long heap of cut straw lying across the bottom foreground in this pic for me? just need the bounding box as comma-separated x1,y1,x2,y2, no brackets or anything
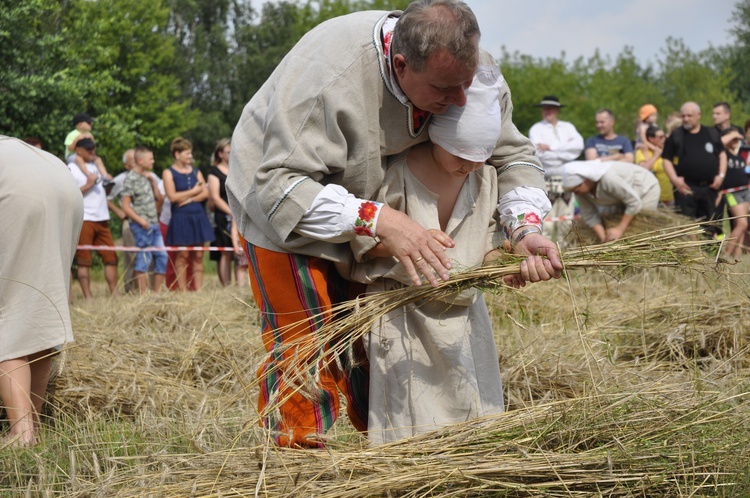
66,385,748,498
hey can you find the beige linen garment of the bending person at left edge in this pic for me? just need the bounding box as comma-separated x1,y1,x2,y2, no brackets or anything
0,136,83,361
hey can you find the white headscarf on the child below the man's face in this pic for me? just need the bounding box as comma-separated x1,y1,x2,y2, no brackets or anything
429,65,504,162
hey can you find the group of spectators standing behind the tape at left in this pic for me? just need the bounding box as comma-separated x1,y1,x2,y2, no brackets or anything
26,113,247,299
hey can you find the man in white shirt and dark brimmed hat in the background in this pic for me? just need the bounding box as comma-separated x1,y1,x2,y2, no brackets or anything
529,95,583,243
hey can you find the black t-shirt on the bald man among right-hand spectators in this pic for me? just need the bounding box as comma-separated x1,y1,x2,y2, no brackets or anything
661,126,724,183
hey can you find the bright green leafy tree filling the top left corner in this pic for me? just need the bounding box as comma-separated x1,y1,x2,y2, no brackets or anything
0,0,197,172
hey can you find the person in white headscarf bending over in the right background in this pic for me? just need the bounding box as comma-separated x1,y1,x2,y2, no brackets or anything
563,160,661,242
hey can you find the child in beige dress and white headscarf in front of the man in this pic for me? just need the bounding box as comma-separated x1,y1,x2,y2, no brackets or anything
351,66,555,443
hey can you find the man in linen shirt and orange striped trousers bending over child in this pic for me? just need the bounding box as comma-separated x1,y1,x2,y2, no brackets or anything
227,0,562,446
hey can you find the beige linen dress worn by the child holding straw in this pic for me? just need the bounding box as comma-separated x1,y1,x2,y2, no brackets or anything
352,154,503,443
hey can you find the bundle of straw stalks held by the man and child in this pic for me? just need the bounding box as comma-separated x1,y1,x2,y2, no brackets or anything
256,224,718,411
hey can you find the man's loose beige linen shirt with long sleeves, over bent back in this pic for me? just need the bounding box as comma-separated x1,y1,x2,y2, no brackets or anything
227,11,544,262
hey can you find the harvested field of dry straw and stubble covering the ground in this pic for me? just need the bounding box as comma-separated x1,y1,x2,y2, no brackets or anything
0,223,750,497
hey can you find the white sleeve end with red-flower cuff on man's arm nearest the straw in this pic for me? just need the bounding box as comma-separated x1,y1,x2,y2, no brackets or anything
294,184,382,243
